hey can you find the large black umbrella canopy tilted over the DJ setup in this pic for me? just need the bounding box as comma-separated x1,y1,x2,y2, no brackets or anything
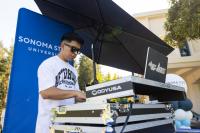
35,0,173,74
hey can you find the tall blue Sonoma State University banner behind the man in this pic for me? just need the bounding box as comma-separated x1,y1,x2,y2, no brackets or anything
3,8,72,133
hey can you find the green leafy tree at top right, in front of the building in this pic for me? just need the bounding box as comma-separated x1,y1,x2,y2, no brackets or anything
165,0,200,46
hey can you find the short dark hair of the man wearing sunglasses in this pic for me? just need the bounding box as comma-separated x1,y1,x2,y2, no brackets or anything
61,32,84,45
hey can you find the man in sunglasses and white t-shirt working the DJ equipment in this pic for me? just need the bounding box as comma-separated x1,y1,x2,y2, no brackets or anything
35,33,86,133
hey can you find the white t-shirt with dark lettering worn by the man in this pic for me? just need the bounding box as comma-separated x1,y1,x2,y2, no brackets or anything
35,56,79,133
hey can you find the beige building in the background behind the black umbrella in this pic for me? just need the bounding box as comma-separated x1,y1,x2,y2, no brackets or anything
133,9,200,114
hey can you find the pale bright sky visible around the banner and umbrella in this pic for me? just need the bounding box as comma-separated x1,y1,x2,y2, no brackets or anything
0,0,169,76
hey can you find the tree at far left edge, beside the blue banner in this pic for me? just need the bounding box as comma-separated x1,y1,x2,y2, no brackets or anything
0,42,13,122
